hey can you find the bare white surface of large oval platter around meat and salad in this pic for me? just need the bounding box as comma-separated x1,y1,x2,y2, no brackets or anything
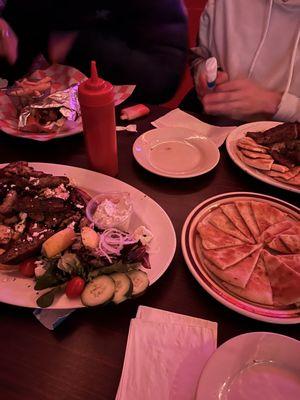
0,163,176,309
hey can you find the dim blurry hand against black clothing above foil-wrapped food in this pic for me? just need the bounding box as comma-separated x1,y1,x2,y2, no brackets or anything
48,32,78,63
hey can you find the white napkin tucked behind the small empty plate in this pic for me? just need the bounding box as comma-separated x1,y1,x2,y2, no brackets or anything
152,108,235,147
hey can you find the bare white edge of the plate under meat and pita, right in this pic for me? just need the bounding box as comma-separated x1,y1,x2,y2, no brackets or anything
226,121,300,193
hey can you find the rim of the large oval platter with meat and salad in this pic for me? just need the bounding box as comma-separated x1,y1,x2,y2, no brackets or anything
0,162,177,310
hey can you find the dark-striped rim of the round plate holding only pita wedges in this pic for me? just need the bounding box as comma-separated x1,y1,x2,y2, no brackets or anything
181,192,300,325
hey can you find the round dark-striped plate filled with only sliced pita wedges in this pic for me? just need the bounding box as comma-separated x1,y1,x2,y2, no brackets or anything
181,192,300,324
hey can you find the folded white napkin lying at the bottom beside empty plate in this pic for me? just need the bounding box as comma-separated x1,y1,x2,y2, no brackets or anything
116,306,217,400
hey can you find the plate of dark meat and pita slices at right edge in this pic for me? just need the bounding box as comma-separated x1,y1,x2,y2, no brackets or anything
226,121,300,193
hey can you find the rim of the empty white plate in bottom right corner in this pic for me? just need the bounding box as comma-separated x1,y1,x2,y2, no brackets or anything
195,331,300,400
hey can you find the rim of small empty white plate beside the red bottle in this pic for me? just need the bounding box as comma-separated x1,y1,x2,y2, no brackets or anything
132,127,220,179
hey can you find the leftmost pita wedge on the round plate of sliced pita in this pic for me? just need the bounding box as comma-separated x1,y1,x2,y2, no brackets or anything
197,222,243,250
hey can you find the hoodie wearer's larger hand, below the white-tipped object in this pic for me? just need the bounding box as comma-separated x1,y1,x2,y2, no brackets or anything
202,79,282,120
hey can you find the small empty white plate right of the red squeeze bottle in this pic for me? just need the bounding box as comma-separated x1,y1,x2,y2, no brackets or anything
133,128,220,178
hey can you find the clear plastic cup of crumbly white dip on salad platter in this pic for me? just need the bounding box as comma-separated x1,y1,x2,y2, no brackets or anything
86,192,132,231
